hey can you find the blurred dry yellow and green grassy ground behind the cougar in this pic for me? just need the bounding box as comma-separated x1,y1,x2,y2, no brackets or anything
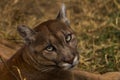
0,0,120,73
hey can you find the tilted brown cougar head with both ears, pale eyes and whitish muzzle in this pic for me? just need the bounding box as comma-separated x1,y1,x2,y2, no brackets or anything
17,5,79,70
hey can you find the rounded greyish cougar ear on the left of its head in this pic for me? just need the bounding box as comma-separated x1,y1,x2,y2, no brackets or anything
17,25,35,45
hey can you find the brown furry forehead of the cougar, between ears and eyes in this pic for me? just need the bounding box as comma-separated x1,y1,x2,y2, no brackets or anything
34,20,73,46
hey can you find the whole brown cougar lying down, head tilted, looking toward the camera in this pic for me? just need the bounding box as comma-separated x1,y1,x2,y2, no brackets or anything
0,5,120,80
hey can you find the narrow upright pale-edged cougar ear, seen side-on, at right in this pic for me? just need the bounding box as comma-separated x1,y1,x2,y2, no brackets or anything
56,4,70,25
